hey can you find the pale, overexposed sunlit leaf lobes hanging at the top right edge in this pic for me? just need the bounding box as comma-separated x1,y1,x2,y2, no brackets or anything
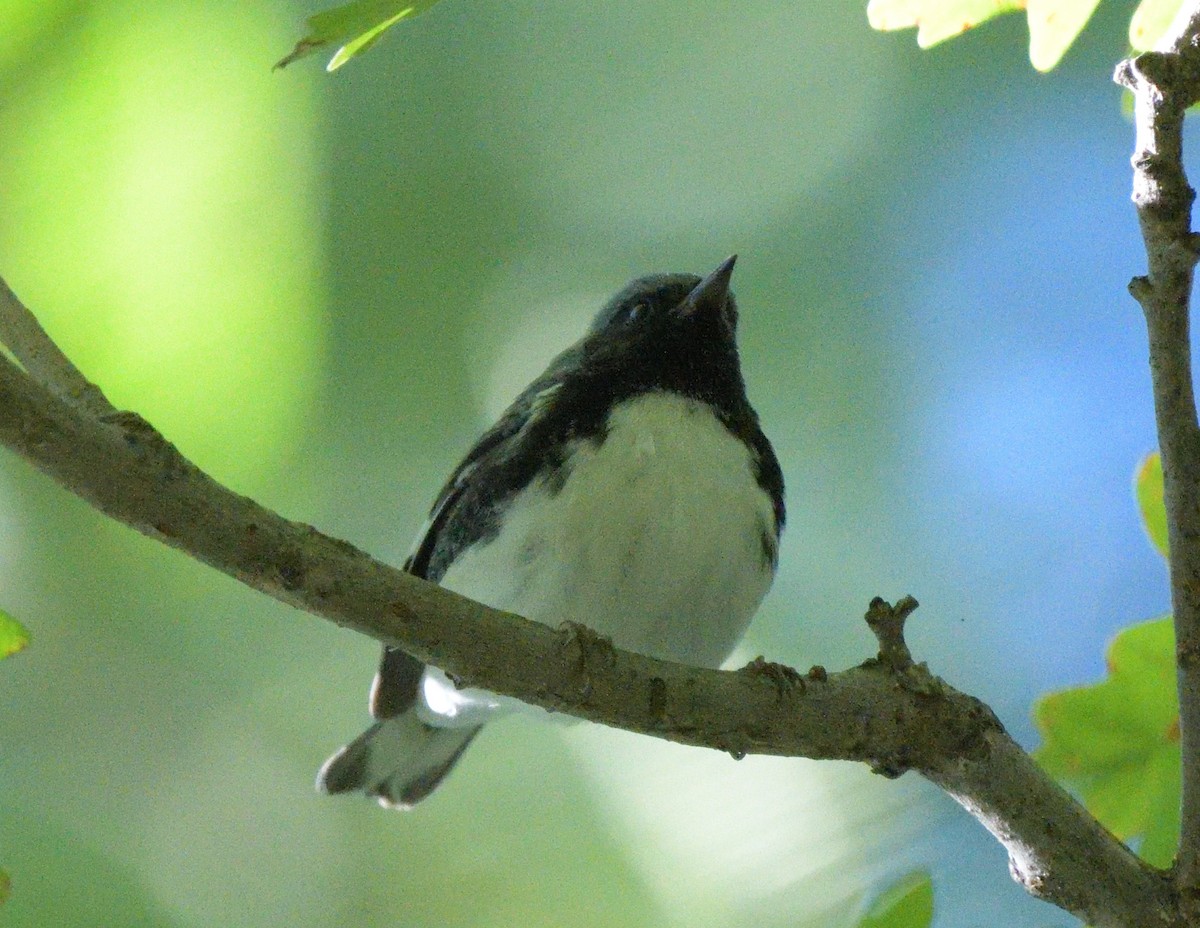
866,0,1182,71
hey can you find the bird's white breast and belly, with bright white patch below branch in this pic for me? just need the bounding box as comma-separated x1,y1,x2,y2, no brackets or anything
425,394,774,724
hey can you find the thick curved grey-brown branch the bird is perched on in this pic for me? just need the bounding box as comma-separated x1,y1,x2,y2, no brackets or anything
0,280,1176,928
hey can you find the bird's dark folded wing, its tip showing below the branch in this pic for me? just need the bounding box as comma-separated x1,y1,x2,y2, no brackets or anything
370,353,569,719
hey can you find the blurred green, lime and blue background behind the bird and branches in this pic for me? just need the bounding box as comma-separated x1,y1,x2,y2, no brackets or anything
0,0,1166,928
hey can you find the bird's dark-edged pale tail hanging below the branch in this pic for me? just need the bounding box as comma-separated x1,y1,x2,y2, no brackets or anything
317,710,481,809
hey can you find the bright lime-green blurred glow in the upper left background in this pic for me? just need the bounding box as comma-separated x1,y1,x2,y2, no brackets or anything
0,0,325,490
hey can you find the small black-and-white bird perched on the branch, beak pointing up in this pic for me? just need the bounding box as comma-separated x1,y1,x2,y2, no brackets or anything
317,255,785,809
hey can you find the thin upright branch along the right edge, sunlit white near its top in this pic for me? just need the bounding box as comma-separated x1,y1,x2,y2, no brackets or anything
1115,0,1200,897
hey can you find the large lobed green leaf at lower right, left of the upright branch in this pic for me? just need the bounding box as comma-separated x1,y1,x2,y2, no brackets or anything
1033,618,1180,867
